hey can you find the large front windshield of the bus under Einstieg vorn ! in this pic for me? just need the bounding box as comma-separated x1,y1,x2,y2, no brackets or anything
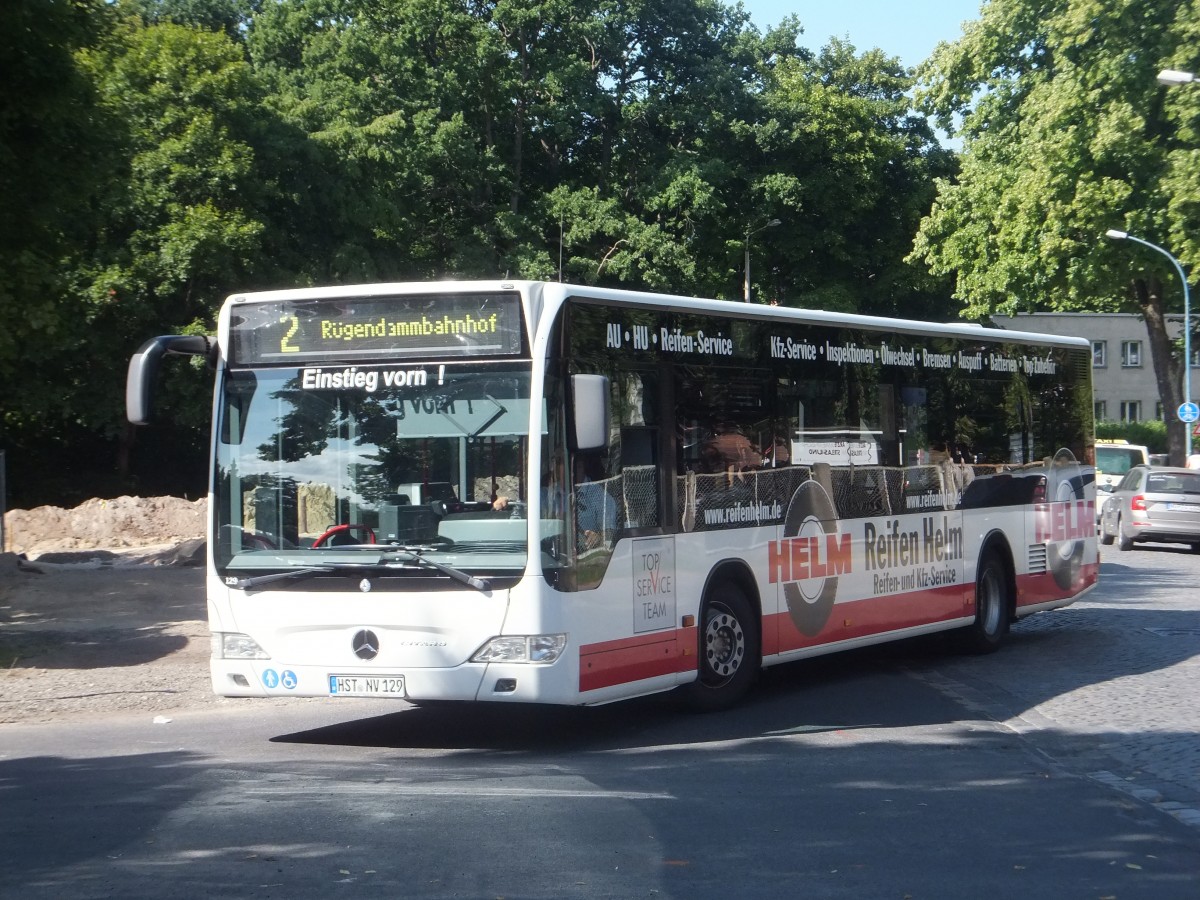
214,362,544,575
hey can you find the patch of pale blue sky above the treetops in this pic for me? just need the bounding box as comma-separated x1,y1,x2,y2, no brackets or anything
742,0,983,66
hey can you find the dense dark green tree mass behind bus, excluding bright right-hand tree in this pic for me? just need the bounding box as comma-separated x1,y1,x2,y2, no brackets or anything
0,0,954,503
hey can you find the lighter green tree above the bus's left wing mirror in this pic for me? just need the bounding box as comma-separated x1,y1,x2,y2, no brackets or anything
76,18,265,432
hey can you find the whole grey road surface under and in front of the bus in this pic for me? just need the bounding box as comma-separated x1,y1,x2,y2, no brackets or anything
0,540,1200,900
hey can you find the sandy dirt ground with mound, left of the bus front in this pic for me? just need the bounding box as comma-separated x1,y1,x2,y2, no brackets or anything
0,497,226,724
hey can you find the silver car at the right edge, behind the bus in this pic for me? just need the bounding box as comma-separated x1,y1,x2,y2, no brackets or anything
1100,466,1200,552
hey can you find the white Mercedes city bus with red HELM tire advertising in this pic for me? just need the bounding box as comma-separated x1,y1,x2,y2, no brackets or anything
126,281,1098,708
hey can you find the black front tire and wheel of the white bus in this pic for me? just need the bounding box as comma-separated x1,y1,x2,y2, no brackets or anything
688,581,762,713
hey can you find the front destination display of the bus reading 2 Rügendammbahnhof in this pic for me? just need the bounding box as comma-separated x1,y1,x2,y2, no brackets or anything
229,292,524,365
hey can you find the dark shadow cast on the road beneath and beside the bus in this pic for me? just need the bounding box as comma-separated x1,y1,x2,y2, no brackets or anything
274,607,1200,754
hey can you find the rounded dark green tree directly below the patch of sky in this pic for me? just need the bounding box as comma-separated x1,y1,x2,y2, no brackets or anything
748,33,954,317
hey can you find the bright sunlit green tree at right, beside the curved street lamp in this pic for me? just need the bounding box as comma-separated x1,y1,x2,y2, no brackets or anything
913,0,1200,462
